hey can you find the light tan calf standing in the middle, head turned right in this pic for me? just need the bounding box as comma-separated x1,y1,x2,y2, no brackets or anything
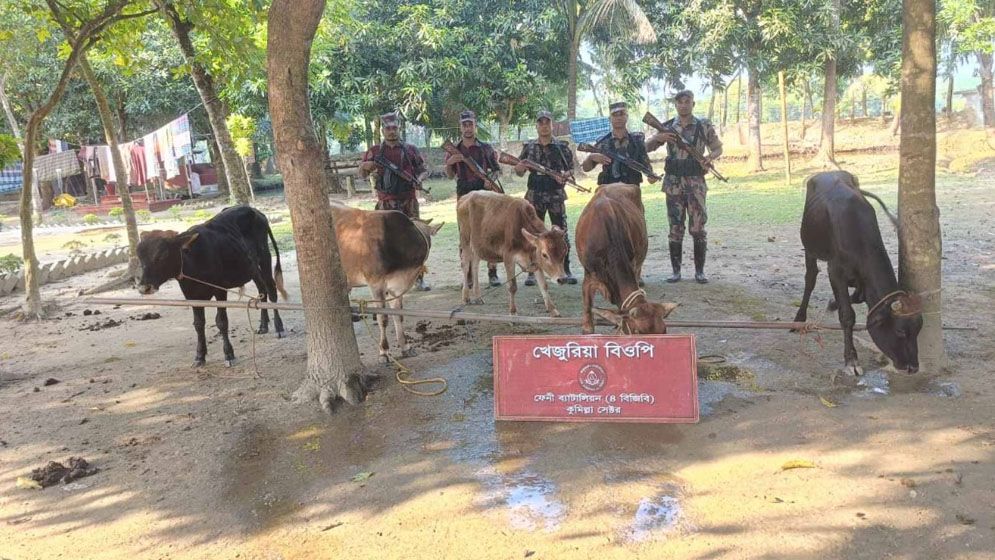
456,191,567,317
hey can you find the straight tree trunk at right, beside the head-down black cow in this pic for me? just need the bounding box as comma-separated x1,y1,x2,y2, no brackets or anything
898,0,947,373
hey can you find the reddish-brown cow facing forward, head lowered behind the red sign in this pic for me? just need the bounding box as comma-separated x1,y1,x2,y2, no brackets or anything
575,184,677,334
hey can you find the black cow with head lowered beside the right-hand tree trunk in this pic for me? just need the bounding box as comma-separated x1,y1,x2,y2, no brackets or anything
795,171,922,375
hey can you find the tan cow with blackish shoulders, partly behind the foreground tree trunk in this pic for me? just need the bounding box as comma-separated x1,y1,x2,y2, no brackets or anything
331,201,443,363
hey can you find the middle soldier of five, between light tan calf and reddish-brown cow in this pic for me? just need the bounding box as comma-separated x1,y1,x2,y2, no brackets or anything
515,111,577,286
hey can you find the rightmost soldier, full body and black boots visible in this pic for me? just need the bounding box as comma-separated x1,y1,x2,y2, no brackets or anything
646,90,722,284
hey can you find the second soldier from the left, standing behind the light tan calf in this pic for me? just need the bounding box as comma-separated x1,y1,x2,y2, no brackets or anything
446,111,501,287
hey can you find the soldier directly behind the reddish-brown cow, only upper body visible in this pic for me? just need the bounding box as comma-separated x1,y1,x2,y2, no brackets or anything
581,101,656,185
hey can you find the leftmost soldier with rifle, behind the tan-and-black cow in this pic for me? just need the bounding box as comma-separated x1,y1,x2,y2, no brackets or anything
359,113,431,291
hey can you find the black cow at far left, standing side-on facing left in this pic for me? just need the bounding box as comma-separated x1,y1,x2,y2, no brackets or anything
138,206,287,367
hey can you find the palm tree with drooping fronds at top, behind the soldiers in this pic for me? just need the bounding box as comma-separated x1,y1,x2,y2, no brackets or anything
556,0,656,120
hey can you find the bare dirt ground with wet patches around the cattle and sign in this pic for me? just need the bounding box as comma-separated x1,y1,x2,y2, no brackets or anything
0,151,995,560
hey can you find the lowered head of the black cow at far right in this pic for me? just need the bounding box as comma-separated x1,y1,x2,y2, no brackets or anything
867,294,922,373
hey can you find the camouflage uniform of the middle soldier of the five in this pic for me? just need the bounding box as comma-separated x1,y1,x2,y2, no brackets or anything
518,138,574,274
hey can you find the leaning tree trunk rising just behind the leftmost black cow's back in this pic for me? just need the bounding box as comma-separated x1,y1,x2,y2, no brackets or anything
155,0,252,204
